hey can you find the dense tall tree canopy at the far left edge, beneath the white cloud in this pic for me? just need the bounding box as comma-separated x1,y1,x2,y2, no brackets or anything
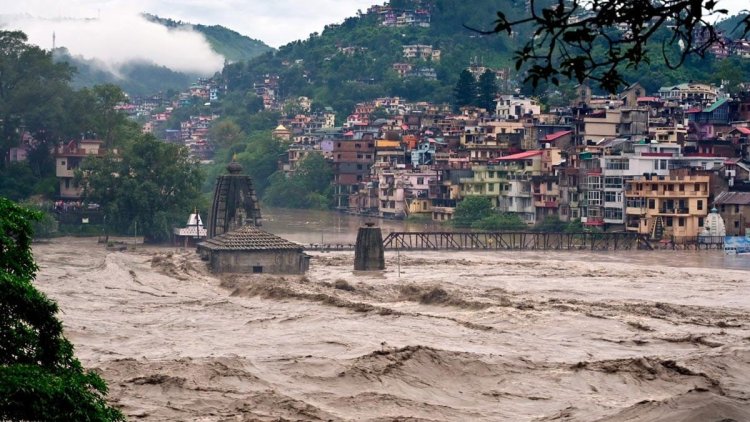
0,31,140,200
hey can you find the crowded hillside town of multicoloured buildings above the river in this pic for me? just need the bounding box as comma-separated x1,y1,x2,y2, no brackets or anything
262,78,750,238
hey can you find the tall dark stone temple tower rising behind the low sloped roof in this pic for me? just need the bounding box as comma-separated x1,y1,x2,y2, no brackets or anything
208,159,260,239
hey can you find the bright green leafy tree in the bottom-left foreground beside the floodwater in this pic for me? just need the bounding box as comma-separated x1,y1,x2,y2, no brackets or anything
0,197,124,421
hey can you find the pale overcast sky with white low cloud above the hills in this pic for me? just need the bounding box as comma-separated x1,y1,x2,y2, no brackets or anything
0,0,750,74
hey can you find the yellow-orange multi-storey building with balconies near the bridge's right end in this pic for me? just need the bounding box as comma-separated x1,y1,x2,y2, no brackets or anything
625,175,709,239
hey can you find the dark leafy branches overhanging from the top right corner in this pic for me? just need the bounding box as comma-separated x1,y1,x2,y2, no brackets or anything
480,0,750,92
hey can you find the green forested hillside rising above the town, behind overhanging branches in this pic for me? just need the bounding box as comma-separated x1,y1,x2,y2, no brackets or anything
224,0,750,115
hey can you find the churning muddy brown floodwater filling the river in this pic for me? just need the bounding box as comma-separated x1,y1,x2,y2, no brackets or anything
34,238,750,422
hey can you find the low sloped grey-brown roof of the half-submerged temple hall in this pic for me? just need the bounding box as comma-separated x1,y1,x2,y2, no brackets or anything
198,225,303,251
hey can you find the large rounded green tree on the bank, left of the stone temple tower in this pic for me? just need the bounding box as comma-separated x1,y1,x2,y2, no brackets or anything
76,135,204,242
